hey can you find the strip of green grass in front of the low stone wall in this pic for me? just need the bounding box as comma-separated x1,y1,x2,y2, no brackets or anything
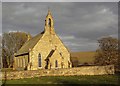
3,75,118,86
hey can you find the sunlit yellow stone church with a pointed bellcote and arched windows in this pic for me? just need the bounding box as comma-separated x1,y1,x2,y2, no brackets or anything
14,11,72,70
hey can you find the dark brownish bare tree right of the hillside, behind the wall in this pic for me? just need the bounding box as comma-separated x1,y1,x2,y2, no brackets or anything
95,37,119,71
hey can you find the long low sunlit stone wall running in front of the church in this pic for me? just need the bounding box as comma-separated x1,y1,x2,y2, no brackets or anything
2,65,114,79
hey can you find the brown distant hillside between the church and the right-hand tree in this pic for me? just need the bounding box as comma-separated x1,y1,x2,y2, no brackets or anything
71,52,95,66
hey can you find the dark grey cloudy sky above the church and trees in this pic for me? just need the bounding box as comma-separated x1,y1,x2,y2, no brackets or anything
2,2,118,51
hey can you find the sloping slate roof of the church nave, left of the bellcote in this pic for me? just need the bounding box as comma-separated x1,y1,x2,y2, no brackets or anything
15,32,44,55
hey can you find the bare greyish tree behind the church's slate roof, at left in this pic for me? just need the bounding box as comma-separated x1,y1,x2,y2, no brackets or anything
2,32,31,68
